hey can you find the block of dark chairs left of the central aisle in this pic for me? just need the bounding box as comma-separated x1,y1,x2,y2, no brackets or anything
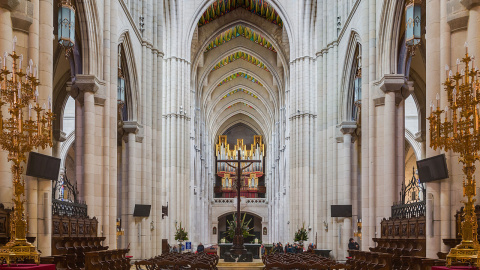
135,252,219,270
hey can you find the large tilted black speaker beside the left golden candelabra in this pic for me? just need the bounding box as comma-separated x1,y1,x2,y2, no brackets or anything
27,152,60,180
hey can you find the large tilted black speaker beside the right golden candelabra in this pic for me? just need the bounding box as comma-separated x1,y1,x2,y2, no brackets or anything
417,154,448,183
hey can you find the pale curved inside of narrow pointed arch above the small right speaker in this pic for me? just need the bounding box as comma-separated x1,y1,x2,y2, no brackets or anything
339,30,362,121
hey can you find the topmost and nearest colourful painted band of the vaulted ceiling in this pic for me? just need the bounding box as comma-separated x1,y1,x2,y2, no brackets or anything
198,0,283,27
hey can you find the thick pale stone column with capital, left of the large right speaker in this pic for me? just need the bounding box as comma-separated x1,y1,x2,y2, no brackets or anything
377,74,406,218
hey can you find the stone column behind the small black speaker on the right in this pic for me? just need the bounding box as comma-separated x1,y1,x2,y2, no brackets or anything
338,121,357,258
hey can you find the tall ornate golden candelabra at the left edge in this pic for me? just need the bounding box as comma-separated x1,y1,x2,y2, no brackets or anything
0,37,53,264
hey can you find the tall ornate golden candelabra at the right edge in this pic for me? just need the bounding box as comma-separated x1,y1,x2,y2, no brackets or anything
427,44,480,266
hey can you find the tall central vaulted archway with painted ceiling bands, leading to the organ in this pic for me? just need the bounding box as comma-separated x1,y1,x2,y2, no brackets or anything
191,0,290,243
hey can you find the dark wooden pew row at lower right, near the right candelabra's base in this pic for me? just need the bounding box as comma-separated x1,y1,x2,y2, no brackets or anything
347,250,446,270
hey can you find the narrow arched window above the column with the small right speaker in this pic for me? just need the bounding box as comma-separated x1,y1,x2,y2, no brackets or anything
350,44,362,121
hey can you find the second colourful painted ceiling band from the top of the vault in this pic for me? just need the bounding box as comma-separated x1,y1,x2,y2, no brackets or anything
205,25,277,52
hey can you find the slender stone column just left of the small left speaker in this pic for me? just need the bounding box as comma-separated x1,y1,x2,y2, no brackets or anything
123,121,139,258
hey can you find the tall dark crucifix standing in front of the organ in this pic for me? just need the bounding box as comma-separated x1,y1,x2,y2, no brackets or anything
217,150,262,255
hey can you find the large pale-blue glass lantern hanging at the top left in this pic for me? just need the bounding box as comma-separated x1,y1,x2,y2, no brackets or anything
58,0,75,58
